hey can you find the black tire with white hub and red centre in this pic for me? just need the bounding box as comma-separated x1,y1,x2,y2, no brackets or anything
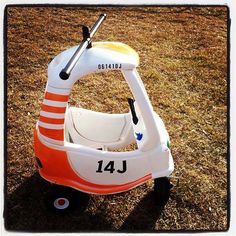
45,185,86,214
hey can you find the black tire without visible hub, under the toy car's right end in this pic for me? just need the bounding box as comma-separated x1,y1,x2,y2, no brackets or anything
154,177,172,207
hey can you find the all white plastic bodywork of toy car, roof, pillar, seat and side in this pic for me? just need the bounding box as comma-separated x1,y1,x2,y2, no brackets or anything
36,42,174,190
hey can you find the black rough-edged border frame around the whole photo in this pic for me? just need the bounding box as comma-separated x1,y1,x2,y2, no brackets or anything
3,3,231,233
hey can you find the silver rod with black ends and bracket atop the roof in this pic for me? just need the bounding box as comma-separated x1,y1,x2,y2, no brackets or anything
59,14,106,80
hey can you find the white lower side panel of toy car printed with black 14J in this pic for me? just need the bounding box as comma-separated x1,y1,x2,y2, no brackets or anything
39,129,174,185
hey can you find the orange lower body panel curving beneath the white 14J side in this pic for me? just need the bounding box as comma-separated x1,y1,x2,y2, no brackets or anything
34,130,151,194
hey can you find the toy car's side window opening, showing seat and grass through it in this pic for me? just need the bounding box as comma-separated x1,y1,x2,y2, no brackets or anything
67,71,137,152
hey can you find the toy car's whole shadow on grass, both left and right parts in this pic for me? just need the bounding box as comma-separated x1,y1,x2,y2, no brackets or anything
4,173,164,232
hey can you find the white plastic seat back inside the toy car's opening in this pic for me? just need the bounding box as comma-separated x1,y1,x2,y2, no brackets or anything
66,107,135,149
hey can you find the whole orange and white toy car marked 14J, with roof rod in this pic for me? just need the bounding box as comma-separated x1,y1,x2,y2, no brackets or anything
34,14,174,211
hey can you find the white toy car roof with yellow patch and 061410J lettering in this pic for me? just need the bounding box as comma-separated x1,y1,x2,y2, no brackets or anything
48,42,139,89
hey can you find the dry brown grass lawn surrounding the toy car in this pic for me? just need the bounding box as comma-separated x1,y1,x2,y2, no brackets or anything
5,7,228,231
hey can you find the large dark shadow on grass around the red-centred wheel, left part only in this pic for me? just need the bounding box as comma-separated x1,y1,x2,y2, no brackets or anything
4,174,112,232
